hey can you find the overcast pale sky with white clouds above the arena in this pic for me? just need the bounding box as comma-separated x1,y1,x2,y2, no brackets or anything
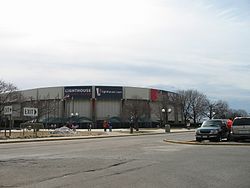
0,0,250,112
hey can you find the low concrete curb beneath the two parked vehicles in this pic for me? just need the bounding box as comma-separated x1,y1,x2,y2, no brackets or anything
163,139,250,146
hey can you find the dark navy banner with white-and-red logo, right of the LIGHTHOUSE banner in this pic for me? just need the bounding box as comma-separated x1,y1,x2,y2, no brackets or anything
95,86,122,99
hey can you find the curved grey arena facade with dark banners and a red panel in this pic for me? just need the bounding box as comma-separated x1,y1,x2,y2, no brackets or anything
12,86,182,128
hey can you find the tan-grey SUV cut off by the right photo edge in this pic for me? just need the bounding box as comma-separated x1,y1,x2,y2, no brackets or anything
230,117,250,141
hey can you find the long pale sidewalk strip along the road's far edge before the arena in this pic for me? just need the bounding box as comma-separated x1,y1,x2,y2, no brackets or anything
0,128,194,144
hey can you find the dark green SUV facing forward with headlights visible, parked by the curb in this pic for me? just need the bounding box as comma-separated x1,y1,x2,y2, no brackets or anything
195,119,229,142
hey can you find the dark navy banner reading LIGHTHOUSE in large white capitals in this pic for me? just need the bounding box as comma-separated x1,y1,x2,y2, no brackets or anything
64,86,92,99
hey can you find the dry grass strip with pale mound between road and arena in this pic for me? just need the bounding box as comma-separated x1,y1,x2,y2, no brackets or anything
0,127,165,144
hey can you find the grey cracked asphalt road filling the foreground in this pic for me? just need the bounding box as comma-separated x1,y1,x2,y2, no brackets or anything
0,133,250,188
